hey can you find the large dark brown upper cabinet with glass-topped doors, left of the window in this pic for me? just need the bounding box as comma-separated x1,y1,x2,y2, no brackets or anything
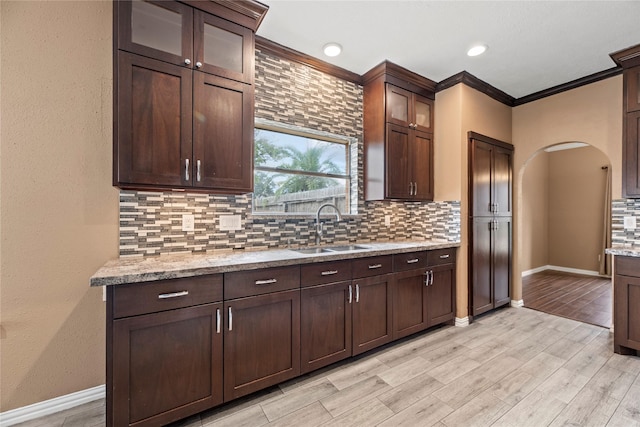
113,0,266,194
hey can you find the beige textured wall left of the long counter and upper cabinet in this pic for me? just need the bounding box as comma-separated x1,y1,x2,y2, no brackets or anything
0,1,118,412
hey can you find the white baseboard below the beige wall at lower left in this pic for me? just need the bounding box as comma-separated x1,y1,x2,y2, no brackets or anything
0,384,106,427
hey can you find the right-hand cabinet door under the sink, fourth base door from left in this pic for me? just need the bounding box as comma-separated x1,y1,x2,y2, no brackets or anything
352,275,392,355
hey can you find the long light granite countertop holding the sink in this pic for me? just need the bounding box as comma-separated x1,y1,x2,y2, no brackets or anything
90,240,460,286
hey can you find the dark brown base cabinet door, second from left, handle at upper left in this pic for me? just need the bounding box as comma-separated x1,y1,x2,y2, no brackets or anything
224,289,300,402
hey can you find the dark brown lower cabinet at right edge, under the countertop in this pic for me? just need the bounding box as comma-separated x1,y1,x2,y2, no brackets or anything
613,256,640,354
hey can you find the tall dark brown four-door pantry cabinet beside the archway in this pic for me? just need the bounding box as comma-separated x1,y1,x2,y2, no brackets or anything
469,132,513,316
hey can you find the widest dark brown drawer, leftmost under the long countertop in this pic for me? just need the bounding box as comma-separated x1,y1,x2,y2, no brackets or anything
113,274,222,319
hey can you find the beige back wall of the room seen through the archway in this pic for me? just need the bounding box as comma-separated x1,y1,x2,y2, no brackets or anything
548,147,609,271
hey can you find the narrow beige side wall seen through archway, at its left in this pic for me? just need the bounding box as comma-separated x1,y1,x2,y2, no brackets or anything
520,151,549,271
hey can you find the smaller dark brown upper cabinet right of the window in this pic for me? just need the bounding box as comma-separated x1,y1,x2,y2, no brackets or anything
363,61,435,201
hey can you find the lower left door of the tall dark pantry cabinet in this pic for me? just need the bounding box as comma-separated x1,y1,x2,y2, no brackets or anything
469,218,494,316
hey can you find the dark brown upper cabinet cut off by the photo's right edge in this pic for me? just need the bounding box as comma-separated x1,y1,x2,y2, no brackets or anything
611,45,640,199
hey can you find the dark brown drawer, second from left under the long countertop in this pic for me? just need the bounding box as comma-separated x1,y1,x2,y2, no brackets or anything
224,266,300,300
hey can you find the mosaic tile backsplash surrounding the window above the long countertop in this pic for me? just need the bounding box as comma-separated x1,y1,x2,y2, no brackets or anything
120,51,460,257
